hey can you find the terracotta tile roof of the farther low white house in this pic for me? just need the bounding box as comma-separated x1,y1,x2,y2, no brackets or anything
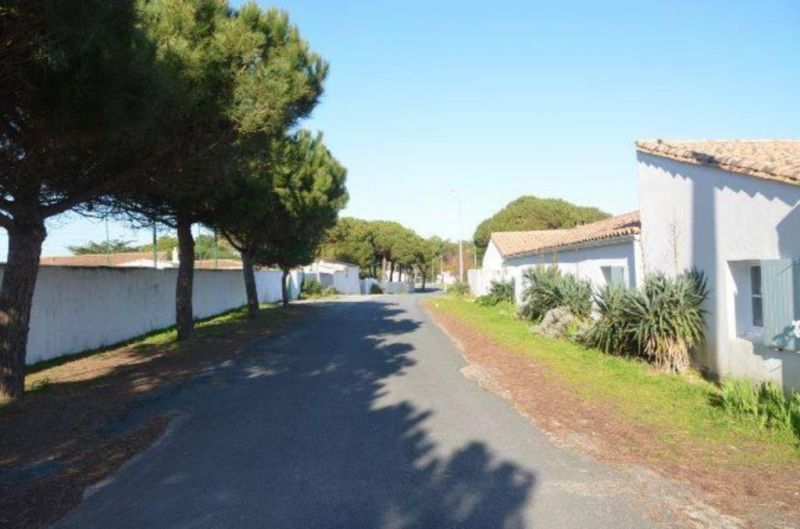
492,211,641,257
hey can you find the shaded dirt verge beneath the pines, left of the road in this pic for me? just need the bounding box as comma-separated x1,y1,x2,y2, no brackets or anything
0,306,300,528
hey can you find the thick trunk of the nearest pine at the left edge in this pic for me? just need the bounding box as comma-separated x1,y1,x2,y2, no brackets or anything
0,220,47,399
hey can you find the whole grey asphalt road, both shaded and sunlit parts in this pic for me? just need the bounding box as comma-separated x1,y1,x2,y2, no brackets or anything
56,295,672,529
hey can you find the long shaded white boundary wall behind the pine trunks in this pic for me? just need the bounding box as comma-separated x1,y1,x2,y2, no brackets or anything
0,266,296,364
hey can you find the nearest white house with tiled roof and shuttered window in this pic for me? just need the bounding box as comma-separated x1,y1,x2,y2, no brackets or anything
636,140,800,388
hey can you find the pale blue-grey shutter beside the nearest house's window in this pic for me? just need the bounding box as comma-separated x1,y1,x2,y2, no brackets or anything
761,259,800,351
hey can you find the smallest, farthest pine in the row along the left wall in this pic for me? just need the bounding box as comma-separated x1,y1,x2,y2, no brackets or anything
255,131,348,307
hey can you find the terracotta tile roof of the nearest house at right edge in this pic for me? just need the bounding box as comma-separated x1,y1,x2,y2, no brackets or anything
636,140,800,185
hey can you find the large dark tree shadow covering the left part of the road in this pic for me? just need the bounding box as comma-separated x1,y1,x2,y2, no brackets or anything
57,299,535,529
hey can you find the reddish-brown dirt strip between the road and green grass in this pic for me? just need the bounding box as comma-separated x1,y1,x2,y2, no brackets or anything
428,306,800,528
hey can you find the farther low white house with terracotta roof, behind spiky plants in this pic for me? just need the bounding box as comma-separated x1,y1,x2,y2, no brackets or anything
469,211,643,300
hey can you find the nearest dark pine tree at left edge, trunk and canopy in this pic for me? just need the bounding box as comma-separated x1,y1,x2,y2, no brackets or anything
0,0,162,398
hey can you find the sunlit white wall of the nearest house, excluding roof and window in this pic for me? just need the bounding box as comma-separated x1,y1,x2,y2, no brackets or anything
638,153,800,388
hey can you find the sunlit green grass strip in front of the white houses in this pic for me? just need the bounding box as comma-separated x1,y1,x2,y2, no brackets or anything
429,297,800,464
